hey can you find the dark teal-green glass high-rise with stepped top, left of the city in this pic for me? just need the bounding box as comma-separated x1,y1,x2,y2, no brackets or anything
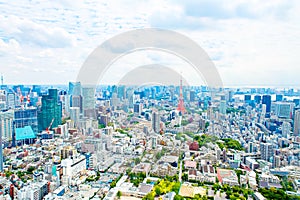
38,89,62,131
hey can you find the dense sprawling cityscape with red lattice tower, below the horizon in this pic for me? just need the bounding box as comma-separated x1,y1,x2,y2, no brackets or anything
0,81,300,200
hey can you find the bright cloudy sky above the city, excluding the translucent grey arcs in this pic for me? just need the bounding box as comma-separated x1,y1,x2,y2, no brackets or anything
0,0,300,88
